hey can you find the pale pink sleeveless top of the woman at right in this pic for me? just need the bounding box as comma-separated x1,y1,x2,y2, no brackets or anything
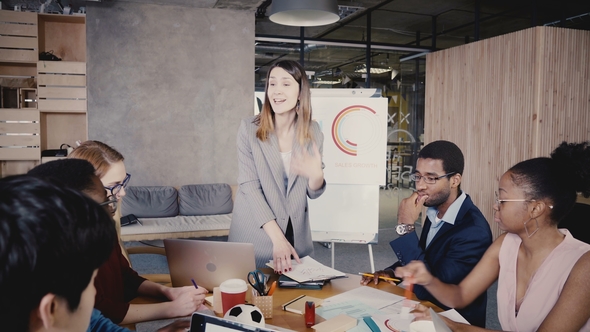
497,229,590,332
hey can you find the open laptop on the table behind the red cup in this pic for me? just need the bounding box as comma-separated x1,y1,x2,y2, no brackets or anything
164,239,256,291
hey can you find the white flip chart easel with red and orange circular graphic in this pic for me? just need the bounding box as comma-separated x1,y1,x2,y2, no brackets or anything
308,89,387,272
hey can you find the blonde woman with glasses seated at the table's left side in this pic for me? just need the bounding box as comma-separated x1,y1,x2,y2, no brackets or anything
68,141,207,324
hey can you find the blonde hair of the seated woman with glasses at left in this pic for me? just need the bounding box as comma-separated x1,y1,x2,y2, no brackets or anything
68,141,125,179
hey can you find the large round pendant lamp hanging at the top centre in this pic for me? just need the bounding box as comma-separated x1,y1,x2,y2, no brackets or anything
269,0,340,27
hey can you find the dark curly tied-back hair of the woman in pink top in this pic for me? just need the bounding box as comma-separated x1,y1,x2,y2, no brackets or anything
508,142,590,224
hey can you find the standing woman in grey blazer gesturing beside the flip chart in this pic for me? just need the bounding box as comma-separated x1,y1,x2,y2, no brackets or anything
229,60,326,273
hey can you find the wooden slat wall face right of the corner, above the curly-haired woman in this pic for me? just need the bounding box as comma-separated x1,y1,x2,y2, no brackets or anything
535,27,590,156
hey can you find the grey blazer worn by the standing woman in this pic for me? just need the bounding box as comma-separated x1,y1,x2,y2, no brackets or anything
229,117,326,267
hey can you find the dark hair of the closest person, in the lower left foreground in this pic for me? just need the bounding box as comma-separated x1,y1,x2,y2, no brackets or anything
0,175,117,331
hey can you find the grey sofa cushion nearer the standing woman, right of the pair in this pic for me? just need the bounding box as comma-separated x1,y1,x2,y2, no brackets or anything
178,183,234,216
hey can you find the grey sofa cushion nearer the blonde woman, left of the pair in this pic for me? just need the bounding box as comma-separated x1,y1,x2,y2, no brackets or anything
121,186,178,218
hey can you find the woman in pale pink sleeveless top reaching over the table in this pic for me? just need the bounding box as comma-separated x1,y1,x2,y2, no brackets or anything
395,142,590,332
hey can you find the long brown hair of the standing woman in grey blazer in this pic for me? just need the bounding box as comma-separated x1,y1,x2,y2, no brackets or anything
254,60,312,145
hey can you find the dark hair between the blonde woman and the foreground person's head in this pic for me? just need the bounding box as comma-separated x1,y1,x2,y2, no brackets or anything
27,159,94,192
